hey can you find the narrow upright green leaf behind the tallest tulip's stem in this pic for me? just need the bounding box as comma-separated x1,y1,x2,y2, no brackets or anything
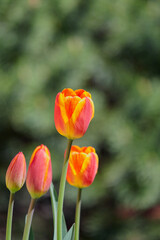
50,183,67,240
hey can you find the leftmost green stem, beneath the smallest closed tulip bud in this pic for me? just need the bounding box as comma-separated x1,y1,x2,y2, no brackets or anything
6,192,14,240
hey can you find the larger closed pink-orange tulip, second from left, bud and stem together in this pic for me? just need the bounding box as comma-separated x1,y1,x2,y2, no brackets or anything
22,144,52,240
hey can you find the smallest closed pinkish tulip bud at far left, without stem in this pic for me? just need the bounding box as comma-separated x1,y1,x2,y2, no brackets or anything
6,152,26,193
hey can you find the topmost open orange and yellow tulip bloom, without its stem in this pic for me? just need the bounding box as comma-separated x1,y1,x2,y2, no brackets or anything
54,88,94,139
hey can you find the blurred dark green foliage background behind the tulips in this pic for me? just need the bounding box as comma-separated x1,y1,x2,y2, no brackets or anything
0,0,160,240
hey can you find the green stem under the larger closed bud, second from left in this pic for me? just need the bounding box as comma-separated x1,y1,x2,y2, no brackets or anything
23,198,36,240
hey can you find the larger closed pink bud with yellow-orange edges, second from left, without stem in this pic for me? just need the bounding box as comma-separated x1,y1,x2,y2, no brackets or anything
26,144,52,199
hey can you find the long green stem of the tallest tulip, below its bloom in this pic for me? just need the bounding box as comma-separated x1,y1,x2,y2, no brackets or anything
57,139,73,240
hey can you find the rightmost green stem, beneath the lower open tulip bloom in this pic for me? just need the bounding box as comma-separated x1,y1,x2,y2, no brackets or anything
74,188,82,240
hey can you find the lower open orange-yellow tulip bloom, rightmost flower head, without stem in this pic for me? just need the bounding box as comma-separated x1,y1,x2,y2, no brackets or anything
67,146,98,188
